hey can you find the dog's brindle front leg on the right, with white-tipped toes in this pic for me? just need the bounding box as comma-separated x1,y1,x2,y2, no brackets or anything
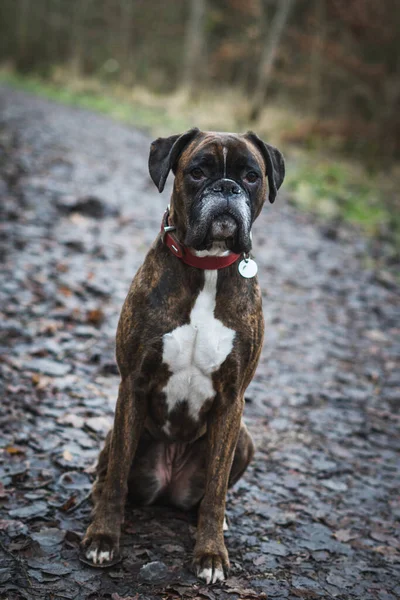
193,398,244,583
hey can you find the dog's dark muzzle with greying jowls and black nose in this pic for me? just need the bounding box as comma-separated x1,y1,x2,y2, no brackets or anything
185,179,251,253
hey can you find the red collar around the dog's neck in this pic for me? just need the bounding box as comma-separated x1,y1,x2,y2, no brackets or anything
161,208,240,270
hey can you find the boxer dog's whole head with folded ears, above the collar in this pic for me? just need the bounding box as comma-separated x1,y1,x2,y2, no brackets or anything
149,128,285,253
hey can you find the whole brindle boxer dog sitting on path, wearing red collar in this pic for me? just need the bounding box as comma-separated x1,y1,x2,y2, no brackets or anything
83,129,284,583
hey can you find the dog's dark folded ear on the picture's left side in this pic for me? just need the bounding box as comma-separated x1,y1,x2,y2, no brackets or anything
149,127,200,192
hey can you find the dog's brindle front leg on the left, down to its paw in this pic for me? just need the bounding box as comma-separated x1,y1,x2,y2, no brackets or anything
83,376,145,566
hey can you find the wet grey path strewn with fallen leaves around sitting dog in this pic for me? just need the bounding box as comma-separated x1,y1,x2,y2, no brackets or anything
0,87,400,600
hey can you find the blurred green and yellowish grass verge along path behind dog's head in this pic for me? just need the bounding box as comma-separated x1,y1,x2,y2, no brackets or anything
0,70,400,253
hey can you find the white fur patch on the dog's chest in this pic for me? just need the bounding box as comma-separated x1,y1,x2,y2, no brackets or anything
163,270,235,433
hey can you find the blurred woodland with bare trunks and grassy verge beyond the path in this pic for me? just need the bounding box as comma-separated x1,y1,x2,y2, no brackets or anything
0,0,400,256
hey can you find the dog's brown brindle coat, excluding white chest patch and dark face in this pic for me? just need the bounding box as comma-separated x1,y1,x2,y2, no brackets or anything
84,130,283,574
